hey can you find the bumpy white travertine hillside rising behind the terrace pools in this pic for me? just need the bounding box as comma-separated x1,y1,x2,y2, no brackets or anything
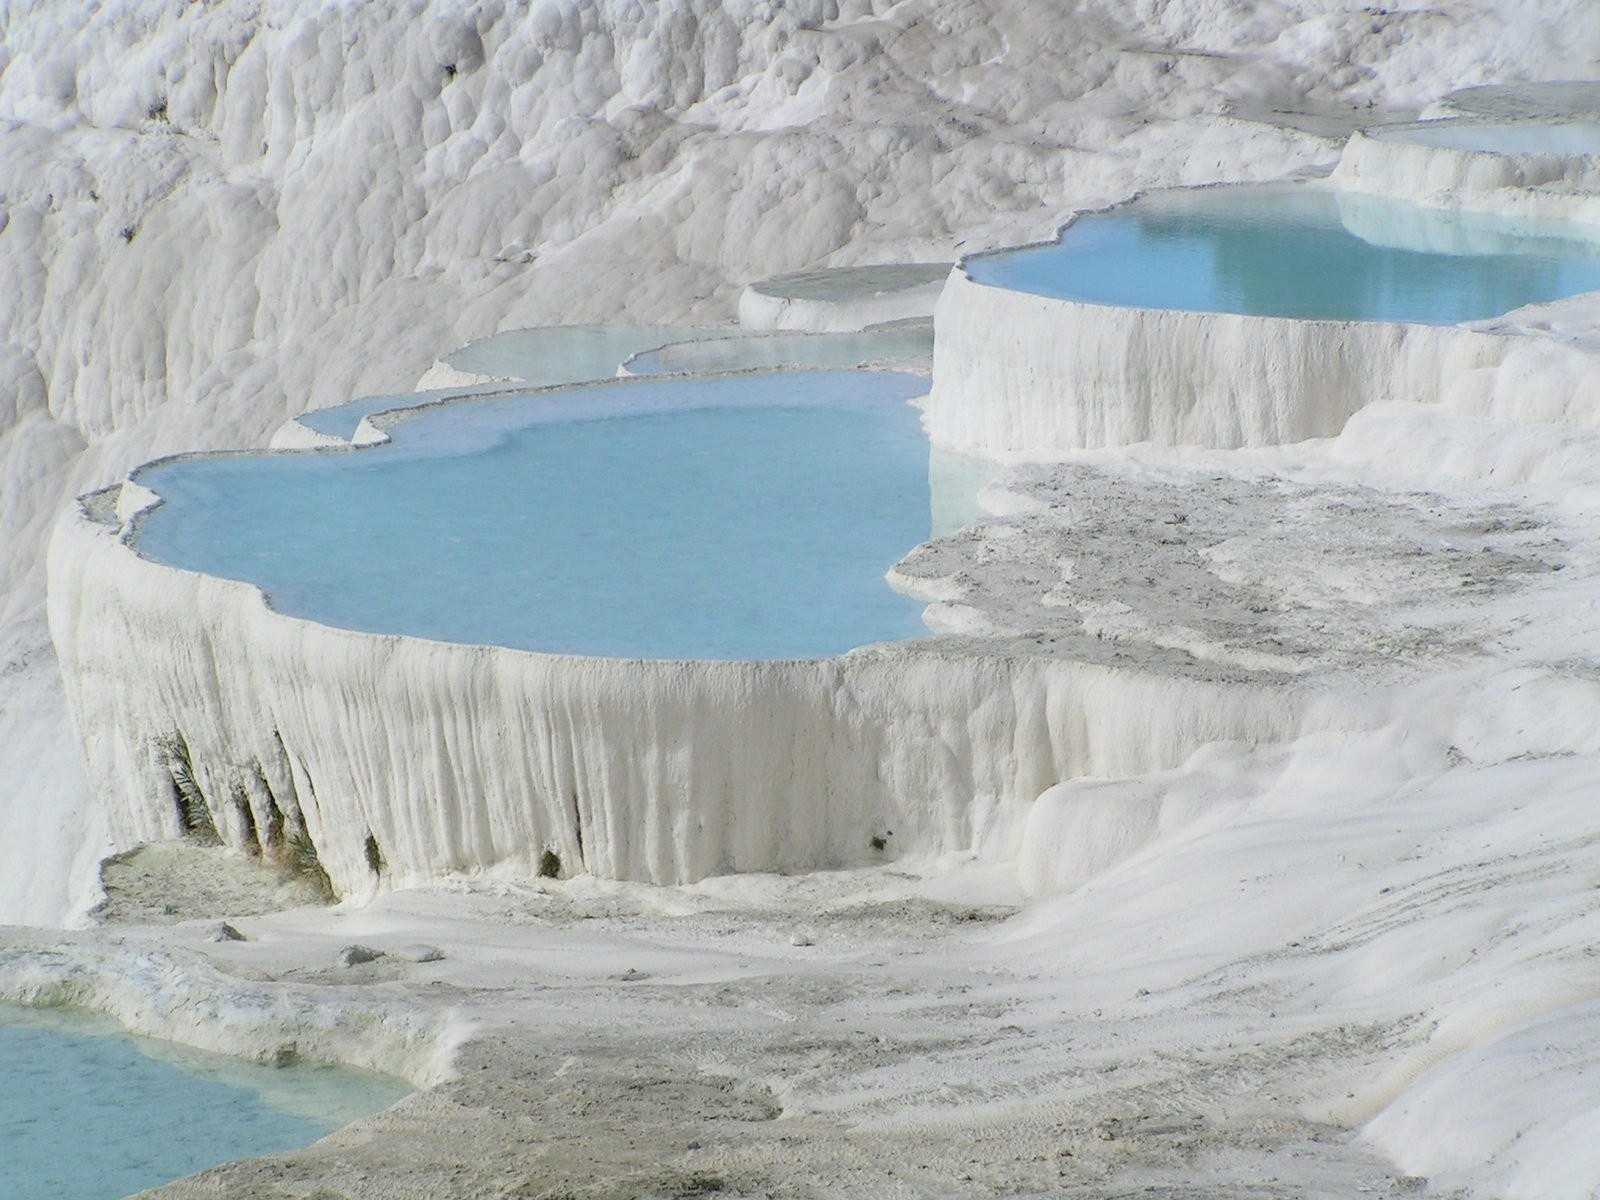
18,0,1555,923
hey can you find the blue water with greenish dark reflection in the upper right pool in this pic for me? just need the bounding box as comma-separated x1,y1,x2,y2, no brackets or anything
968,184,1600,325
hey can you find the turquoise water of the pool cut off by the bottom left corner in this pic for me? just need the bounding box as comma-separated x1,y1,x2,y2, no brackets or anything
0,1010,406,1200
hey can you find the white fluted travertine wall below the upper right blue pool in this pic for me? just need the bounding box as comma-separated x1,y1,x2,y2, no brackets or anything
926,256,1600,454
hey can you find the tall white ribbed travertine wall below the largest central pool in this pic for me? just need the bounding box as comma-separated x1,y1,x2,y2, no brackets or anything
50,489,1354,894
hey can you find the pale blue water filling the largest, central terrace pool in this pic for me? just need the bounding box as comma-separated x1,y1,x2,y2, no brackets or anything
138,371,930,659
